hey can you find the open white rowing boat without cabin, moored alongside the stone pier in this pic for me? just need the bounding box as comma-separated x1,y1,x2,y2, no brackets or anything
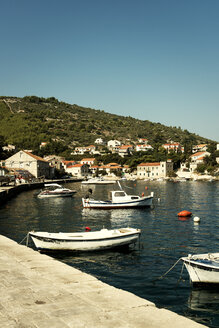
29,228,141,251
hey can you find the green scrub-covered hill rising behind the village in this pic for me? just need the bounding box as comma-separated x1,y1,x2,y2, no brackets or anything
0,96,210,153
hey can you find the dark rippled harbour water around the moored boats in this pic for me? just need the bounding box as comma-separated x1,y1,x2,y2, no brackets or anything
0,181,219,327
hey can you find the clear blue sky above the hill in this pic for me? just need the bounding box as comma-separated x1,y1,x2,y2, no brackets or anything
0,0,219,142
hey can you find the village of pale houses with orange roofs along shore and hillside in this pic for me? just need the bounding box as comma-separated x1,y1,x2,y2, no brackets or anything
0,138,219,183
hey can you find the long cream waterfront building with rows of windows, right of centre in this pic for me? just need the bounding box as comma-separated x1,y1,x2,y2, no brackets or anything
137,161,173,179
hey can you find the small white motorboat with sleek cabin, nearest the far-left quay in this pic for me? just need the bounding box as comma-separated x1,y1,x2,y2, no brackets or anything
38,183,76,198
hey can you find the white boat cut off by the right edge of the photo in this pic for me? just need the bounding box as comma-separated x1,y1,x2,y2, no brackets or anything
181,253,219,285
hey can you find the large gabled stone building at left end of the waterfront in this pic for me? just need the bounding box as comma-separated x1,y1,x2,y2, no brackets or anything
5,150,52,178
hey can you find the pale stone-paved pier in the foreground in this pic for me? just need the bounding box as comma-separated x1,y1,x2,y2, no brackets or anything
0,235,204,328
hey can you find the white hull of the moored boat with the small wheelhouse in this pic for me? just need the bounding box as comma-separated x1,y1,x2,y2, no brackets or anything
82,196,153,209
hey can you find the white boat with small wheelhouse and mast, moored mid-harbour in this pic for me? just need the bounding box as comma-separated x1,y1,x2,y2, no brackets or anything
82,182,154,209
